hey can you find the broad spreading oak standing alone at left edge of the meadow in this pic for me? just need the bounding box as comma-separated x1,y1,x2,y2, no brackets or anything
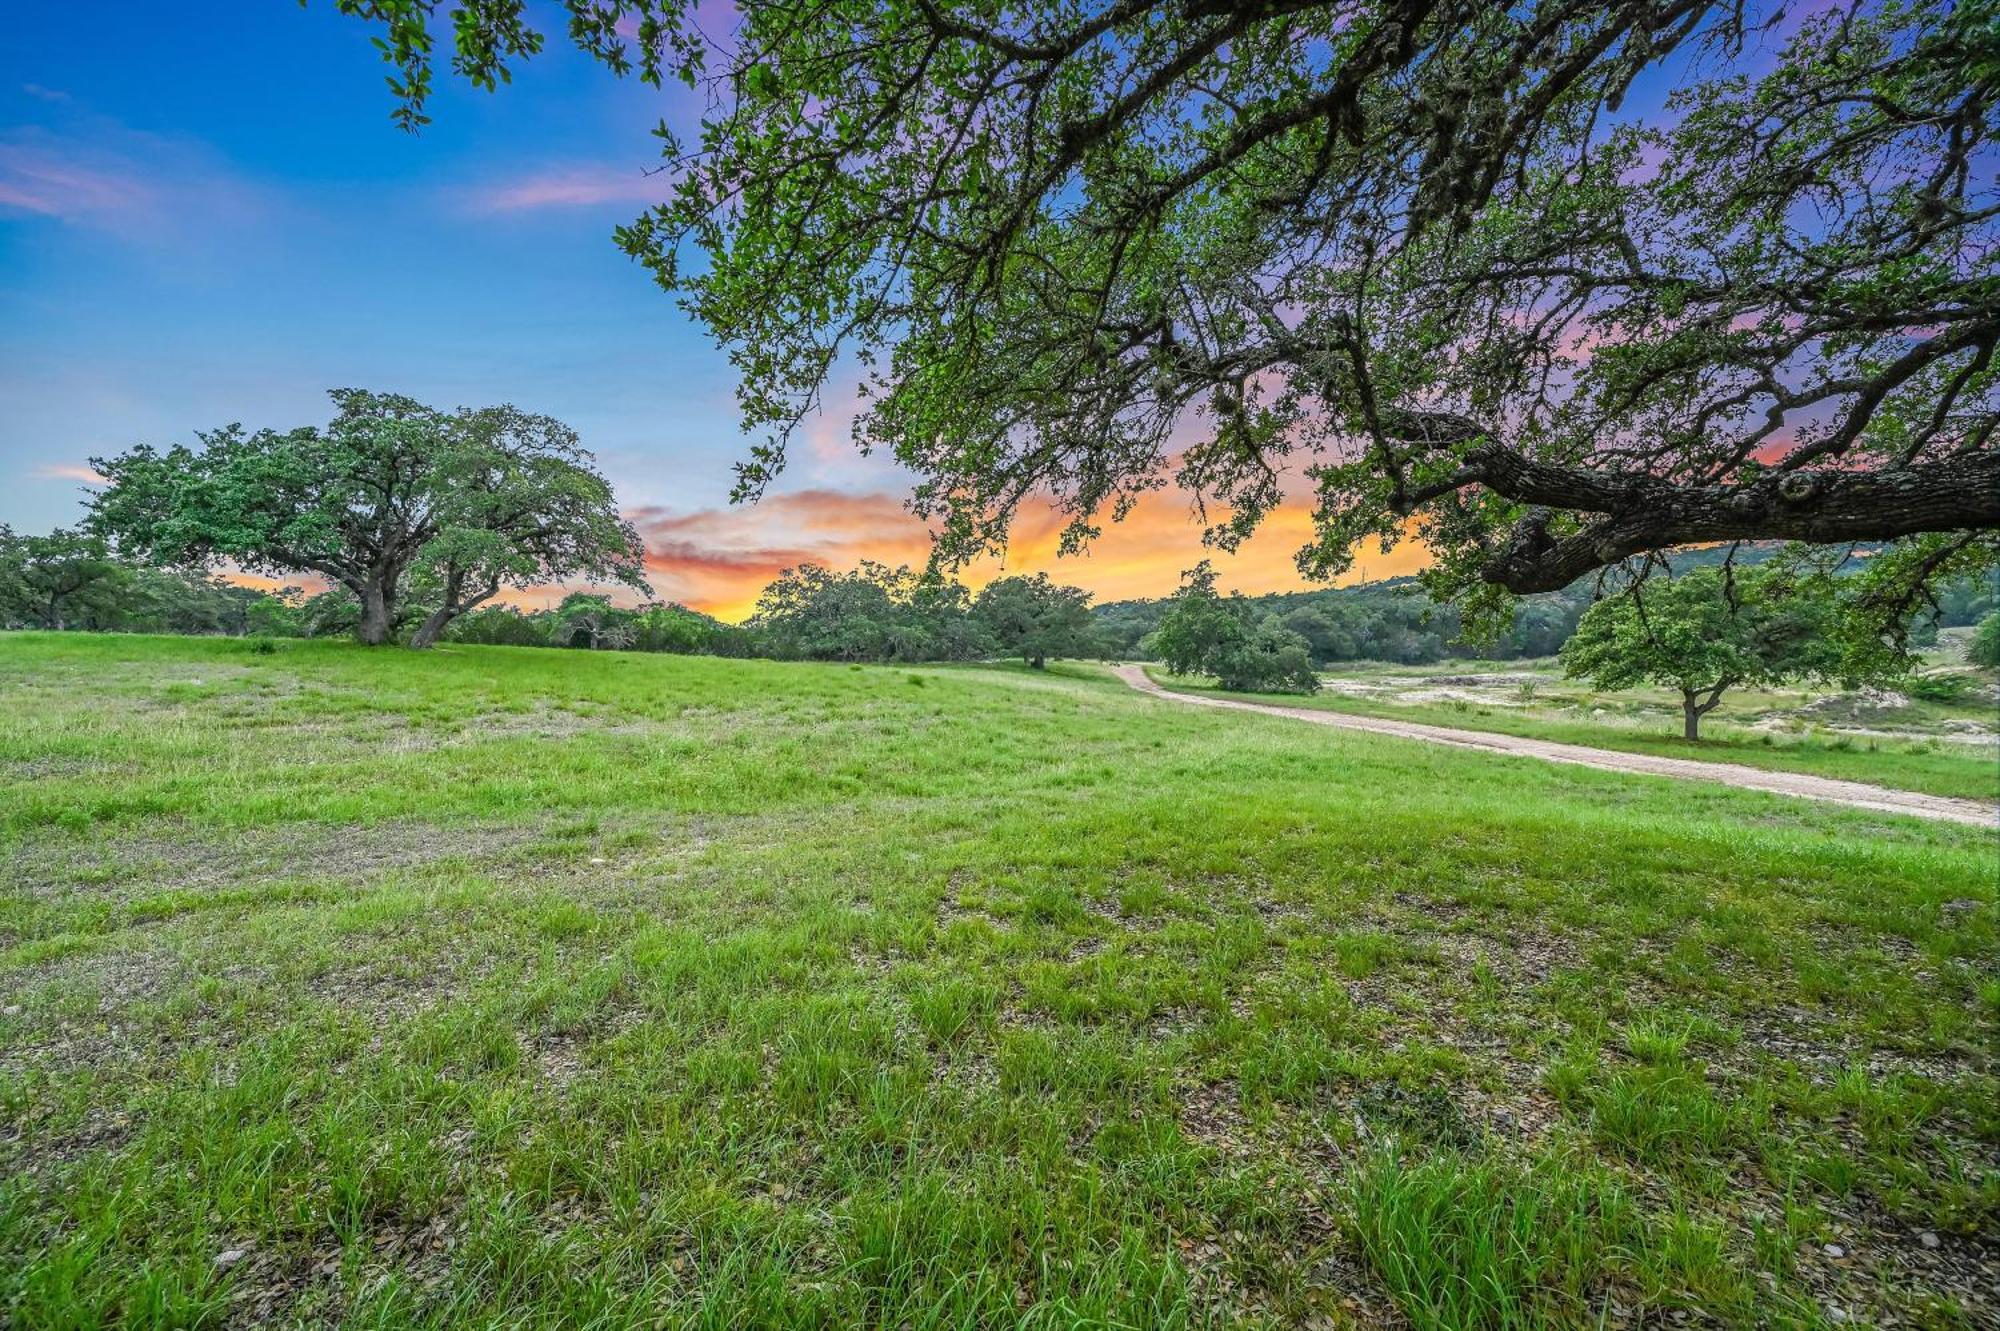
92,390,646,648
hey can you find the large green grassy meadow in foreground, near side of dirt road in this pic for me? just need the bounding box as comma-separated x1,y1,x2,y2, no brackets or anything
0,636,2000,1329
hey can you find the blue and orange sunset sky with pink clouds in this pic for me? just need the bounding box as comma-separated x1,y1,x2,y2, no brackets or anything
0,0,1456,618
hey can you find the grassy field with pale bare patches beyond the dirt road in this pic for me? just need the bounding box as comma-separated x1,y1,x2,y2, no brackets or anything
1148,662,2000,801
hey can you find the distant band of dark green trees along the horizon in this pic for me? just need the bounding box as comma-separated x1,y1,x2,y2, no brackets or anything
0,505,1994,693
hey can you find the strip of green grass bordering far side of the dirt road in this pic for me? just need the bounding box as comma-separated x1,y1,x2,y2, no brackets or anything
1150,667,2000,801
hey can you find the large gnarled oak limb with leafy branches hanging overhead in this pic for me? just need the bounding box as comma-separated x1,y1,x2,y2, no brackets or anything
342,0,2000,623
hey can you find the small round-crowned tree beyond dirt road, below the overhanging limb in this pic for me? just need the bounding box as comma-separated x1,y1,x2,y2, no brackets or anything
1562,568,1848,739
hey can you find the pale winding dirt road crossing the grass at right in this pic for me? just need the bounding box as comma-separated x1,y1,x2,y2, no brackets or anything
1116,666,2000,827
